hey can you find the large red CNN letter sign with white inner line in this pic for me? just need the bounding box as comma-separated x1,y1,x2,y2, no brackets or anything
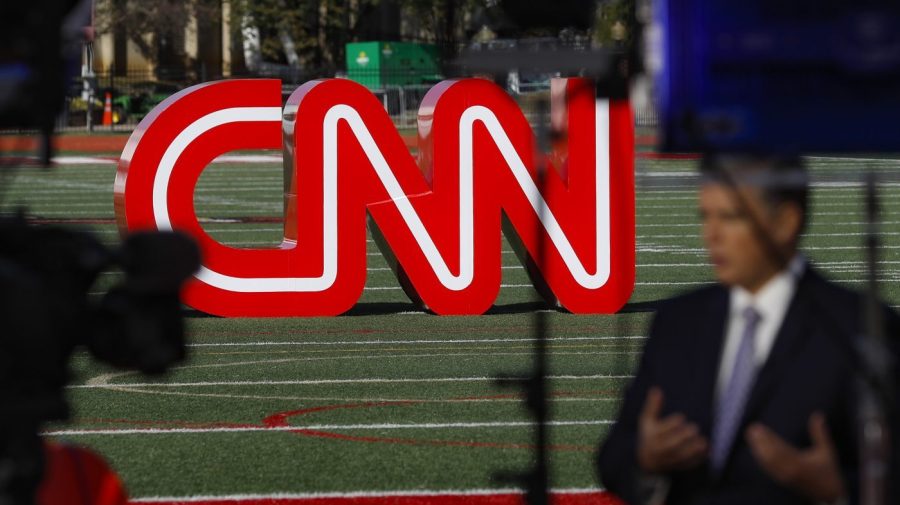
115,79,635,316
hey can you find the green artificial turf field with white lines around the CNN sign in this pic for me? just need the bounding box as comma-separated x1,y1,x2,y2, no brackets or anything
2,151,900,498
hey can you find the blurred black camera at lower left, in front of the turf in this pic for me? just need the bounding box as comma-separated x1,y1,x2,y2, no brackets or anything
0,216,200,505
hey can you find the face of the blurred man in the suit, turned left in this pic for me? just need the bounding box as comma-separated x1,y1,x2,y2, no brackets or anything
700,182,779,292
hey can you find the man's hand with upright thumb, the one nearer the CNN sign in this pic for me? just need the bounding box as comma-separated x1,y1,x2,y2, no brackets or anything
637,387,709,473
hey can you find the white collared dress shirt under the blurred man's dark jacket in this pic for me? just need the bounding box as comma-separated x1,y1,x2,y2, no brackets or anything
716,254,806,398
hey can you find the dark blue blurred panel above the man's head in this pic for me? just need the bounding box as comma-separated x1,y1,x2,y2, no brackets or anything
656,0,900,153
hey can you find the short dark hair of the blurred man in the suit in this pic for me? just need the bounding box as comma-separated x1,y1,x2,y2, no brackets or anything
700,154,809,233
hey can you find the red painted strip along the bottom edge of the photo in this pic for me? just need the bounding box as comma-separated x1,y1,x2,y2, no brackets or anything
131,491,624,505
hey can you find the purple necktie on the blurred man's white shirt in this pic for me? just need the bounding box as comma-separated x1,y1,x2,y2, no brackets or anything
710,307,760,472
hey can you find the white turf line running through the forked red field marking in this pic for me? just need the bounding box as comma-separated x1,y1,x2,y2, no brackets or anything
42,419,615,437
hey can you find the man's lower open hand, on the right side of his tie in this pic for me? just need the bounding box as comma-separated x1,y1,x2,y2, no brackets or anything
746,412,844,503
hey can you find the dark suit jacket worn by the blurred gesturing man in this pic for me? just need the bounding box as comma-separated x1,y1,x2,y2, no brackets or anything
598,267,900,505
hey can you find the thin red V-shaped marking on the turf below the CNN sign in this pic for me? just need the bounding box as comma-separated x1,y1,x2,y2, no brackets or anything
263,394,596,452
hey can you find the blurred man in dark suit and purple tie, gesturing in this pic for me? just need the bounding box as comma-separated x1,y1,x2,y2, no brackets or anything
599,156,900,505
